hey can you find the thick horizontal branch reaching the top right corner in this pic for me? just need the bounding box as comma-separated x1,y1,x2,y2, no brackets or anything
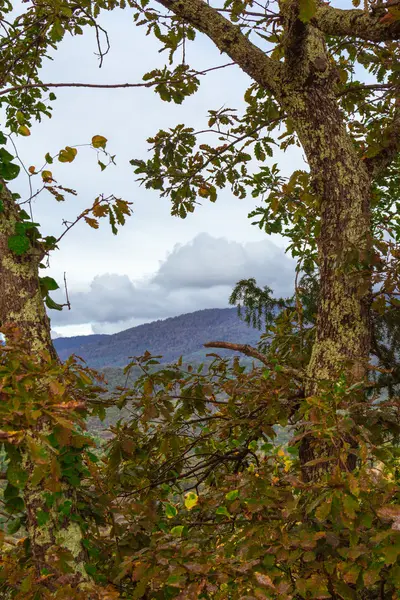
312,4,400,42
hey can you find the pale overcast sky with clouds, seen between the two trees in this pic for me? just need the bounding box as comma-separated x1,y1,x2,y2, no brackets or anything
9,4,303,335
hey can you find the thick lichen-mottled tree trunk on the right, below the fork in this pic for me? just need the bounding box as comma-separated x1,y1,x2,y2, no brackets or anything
282,74,371,480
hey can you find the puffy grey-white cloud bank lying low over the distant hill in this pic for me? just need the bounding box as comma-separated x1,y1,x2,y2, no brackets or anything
50,233,294,335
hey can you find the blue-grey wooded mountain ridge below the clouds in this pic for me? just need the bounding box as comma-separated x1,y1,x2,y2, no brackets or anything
54,308,260,369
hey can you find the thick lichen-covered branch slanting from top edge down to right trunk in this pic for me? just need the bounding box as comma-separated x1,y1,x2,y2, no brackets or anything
157,0,283,94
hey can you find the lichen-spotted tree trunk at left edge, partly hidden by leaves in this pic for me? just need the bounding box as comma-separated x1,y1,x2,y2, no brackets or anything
0,183,91,588
